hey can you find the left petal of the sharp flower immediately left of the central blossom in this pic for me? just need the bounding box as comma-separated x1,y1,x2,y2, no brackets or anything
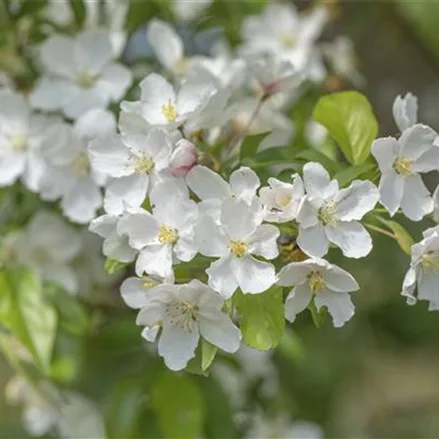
117,210,159,249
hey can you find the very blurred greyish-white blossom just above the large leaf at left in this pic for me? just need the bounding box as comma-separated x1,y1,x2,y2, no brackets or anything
12,211,81,293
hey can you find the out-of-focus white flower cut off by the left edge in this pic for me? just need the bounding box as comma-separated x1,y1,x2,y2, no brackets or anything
0,90,57,192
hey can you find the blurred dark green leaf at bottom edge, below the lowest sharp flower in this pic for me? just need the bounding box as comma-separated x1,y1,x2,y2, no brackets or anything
151,372,204,439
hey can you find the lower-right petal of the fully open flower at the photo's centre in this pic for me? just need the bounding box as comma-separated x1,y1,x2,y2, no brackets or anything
229,256,277,294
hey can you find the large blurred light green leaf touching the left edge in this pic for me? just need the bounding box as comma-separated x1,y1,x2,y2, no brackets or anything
0,267,57,373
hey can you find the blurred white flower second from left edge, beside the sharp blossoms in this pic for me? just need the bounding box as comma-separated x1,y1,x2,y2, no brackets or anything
40,109,116,224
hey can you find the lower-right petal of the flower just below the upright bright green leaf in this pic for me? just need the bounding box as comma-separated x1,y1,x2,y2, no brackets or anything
325,221,372,259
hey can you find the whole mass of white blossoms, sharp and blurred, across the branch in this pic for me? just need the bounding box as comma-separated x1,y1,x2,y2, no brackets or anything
0,0,439,436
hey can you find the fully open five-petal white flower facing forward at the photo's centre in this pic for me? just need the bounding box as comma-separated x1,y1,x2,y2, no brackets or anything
195,198,279,299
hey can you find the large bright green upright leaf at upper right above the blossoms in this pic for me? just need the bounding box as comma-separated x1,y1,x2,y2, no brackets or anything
313,91,378,165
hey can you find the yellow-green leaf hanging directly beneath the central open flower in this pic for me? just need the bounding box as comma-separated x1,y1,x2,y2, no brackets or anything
236,286,285,351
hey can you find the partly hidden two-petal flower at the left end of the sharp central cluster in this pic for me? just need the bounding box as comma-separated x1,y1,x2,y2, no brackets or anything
89,215,137,263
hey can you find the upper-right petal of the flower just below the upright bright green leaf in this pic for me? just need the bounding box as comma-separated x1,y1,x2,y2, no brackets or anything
336,180,380,221
